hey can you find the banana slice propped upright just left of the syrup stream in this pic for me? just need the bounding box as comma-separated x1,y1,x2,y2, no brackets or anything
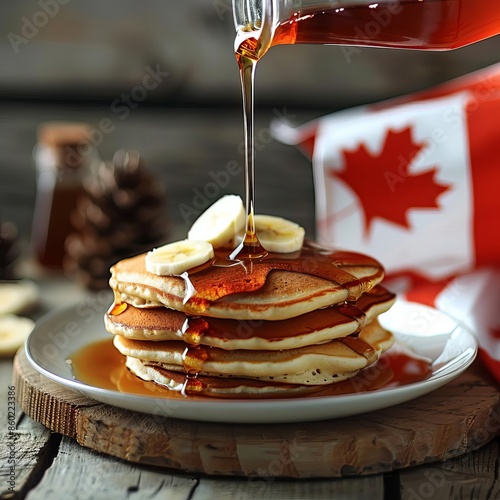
188,194,246,248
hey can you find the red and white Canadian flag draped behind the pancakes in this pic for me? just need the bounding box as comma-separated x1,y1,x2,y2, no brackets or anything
274,64,500,380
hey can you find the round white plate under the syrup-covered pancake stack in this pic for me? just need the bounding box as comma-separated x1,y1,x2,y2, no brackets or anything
26,299,477,423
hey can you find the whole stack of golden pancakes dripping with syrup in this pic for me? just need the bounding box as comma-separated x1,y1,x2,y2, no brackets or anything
105,243,395,397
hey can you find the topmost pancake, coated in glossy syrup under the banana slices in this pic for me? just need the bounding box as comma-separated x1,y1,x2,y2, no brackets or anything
110,244,383,321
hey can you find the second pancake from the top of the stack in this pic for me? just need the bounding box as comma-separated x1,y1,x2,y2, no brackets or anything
105,285,395,350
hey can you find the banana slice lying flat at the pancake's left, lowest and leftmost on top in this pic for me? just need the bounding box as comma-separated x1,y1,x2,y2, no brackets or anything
146,240,214,276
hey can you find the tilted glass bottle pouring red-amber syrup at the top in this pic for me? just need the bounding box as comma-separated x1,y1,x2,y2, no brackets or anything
233,0,500,51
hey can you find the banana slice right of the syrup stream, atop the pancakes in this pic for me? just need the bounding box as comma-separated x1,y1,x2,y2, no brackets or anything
255,215,305,253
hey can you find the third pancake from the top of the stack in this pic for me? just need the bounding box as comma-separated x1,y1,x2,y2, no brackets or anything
114,320,394,385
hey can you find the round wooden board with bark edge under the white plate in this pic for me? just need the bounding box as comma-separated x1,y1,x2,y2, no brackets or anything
14,350,500,480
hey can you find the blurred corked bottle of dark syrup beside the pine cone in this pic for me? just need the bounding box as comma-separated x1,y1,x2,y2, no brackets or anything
31,122,97,269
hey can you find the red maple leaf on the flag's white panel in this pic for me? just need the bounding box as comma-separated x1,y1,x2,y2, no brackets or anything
329,127,450,232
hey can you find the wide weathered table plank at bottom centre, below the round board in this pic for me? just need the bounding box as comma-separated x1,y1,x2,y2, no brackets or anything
21,438,384,500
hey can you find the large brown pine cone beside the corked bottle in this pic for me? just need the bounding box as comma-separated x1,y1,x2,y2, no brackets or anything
64,151,166,290
